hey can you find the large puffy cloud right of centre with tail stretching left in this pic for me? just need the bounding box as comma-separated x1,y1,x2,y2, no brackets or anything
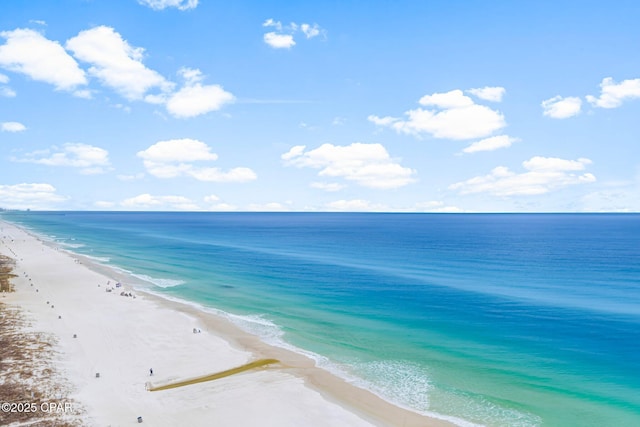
369,89,506,140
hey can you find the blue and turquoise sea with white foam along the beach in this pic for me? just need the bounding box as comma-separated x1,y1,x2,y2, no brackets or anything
2,212,640,426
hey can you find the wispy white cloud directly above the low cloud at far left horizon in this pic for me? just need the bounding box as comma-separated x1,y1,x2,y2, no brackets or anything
13,143,110,175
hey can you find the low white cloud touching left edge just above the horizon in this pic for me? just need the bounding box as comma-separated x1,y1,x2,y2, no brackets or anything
0,183,67,209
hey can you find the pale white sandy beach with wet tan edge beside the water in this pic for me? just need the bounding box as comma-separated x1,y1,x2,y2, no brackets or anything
0,222,452,426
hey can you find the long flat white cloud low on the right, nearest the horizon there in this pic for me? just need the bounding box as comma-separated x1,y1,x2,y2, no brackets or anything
449,156,596,196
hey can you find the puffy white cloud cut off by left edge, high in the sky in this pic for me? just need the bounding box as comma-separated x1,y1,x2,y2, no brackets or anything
0,29,87,91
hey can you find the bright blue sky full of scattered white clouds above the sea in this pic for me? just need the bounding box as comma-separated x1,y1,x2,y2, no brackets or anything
0,0,640,212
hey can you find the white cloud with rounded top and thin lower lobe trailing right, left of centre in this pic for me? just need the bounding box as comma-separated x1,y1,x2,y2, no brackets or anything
137,138,257,182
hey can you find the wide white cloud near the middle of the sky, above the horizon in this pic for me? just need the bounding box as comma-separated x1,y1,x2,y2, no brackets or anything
281,142,416,189
